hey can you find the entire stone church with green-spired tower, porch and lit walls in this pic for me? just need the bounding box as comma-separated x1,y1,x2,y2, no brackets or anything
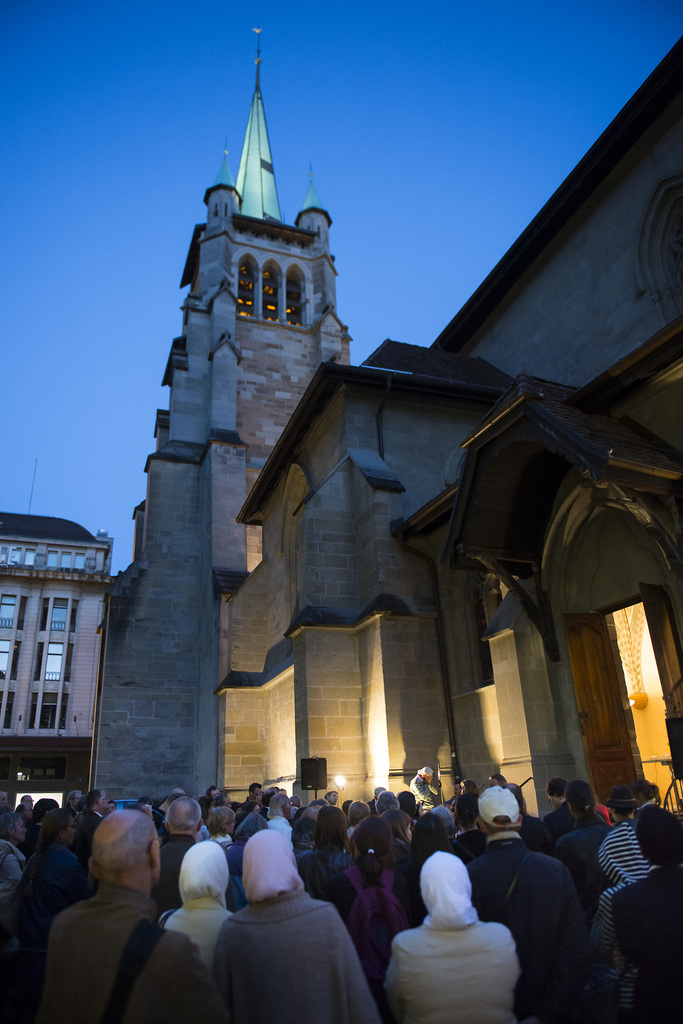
93,44,683,807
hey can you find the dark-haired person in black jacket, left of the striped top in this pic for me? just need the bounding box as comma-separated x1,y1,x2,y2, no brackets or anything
553,779,609,928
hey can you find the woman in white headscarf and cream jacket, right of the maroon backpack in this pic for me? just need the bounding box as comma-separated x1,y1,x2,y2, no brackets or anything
386,852,519,1024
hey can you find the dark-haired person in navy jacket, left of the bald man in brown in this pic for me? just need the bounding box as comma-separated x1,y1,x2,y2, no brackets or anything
18,801,92,1021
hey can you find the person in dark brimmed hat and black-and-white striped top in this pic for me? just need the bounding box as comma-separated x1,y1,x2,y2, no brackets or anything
591,785,650,1019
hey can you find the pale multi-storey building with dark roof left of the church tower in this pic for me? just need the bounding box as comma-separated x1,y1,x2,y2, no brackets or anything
0,512,113,799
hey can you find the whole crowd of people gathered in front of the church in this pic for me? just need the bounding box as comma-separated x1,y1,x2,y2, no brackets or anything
0,766,683,1024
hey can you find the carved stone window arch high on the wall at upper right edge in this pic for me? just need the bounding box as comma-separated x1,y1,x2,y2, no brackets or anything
639,174,683,325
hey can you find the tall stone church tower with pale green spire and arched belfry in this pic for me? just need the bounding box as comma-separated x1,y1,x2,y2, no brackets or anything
91,53,350,796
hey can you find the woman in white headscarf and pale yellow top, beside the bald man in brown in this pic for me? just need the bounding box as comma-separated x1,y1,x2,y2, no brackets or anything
159,831,231,971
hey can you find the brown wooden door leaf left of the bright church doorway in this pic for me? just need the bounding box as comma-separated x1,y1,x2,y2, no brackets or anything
564,613,636,801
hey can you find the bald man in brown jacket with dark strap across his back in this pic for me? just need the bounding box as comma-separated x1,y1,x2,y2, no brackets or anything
36,811,227,1024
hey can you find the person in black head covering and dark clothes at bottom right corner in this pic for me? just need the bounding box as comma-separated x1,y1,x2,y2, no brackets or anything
612,805,683,1024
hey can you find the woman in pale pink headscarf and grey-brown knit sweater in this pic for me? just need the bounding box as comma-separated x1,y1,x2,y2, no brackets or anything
212,829,380,1024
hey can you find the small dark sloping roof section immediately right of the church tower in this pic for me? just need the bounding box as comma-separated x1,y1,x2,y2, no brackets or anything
362,338,510,387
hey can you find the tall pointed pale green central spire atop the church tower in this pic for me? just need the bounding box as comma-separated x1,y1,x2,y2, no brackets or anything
237,29,283,220
